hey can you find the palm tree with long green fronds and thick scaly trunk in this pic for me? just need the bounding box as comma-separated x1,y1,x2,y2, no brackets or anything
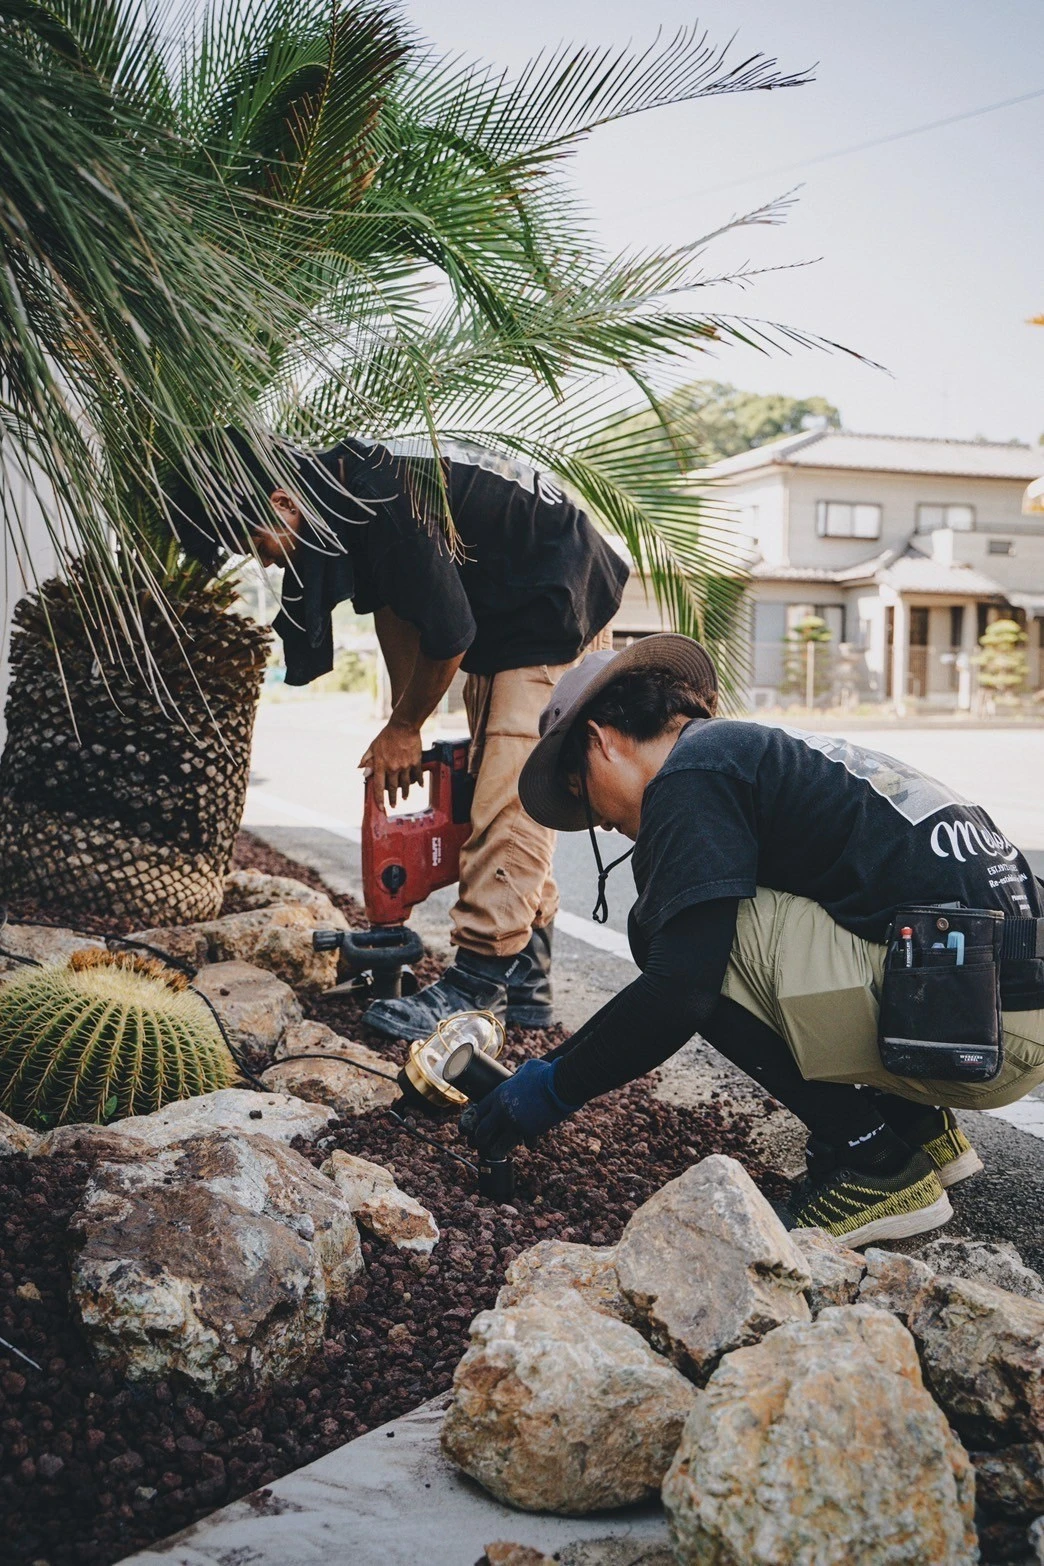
0,0,832,921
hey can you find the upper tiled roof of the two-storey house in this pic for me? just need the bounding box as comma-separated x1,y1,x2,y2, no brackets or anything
692,429,1044,484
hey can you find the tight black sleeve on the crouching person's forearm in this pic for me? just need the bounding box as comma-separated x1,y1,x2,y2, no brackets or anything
546,897,739,1104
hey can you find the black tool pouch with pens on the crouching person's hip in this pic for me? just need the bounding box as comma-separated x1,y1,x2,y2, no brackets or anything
878,905,1003,1082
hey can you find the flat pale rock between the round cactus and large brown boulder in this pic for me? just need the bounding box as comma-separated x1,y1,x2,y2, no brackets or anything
105,1087,337,1148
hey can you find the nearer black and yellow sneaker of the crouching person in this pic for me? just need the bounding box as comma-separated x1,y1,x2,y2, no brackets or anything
794,1145,953,1245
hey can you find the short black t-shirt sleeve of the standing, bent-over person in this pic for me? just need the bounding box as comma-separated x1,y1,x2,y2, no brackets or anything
355,488,476,661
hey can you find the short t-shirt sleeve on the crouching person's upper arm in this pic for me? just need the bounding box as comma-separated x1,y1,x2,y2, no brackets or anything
632,767,758,941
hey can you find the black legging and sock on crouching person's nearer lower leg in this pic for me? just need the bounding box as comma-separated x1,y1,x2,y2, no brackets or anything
701,996,909,1175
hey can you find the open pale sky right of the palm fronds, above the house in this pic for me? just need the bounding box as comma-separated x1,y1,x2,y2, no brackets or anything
405,0,1044,445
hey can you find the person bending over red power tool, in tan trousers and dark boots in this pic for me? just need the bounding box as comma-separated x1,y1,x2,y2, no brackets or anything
171,440,628,1038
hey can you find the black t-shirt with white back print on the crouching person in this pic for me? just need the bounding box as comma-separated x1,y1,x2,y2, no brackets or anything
632,719,1044,941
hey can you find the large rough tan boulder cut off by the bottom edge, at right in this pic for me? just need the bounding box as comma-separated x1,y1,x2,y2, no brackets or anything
664,1304,978,1566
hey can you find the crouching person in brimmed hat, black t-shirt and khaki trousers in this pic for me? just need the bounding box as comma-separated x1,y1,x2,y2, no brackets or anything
471,636,1044,1245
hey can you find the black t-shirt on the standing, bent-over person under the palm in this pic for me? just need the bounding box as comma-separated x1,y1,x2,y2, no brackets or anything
322,442,628,673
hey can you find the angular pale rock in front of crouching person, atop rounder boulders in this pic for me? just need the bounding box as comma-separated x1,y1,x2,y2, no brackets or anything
617,1153,812,1381
